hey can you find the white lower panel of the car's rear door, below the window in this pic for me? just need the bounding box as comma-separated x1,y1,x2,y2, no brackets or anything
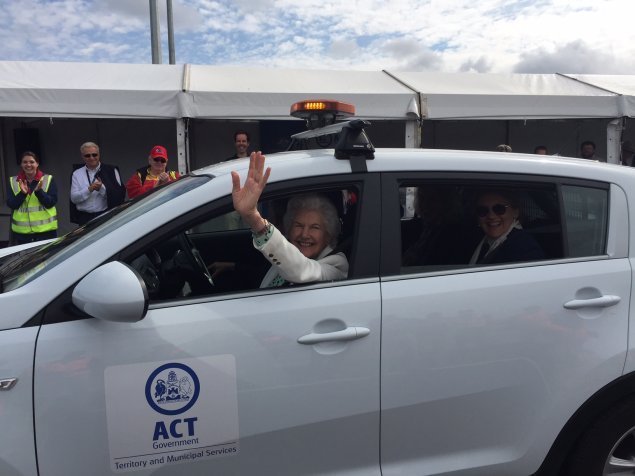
381,259,631,476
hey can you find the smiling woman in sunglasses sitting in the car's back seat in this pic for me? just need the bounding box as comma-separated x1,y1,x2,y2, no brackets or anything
470,190,545,264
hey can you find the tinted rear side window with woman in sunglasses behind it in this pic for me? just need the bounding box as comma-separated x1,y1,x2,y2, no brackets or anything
399,180,608,274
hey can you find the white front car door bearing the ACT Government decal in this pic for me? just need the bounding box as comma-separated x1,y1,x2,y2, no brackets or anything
35,177,380,476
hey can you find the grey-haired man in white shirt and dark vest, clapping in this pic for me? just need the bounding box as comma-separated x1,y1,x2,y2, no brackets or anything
70,142,126,225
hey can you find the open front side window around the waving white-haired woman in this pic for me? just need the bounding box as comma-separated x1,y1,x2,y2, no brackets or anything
128,186,361,301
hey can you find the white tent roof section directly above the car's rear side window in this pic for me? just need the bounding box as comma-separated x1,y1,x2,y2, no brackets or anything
390,72,619,119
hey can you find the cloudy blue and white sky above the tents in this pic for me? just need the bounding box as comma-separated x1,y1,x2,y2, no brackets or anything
0,0,635,74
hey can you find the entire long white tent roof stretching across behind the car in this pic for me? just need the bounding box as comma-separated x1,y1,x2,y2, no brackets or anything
0,61,635,120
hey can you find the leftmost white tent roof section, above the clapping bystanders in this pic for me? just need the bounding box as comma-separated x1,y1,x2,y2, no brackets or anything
0,61,183,117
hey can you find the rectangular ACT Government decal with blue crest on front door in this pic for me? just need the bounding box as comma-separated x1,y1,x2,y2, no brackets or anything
104,355,239,473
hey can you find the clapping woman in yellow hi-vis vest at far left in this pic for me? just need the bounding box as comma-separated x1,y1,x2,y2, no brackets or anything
7,151,57,245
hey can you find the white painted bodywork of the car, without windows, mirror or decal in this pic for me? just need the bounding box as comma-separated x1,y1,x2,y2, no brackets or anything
0,149,635,476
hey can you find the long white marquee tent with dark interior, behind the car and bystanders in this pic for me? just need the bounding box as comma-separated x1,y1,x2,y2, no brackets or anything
0,61,635,241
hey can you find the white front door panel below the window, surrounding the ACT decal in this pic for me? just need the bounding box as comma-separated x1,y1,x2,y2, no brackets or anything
35,283,380,476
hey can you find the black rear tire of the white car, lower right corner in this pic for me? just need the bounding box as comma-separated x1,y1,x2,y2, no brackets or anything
565,397,635,476
